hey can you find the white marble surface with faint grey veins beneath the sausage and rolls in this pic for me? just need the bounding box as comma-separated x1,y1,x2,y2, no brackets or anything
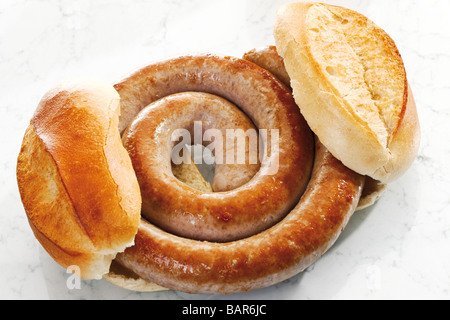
0,0,450,299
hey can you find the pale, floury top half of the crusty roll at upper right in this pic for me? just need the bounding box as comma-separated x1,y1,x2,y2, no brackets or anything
274,2,420,183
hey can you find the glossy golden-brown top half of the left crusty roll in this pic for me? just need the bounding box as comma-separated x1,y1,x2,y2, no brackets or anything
17,81,141,279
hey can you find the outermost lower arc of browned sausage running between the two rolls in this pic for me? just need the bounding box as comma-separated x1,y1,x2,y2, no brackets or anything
116,139,363,294
